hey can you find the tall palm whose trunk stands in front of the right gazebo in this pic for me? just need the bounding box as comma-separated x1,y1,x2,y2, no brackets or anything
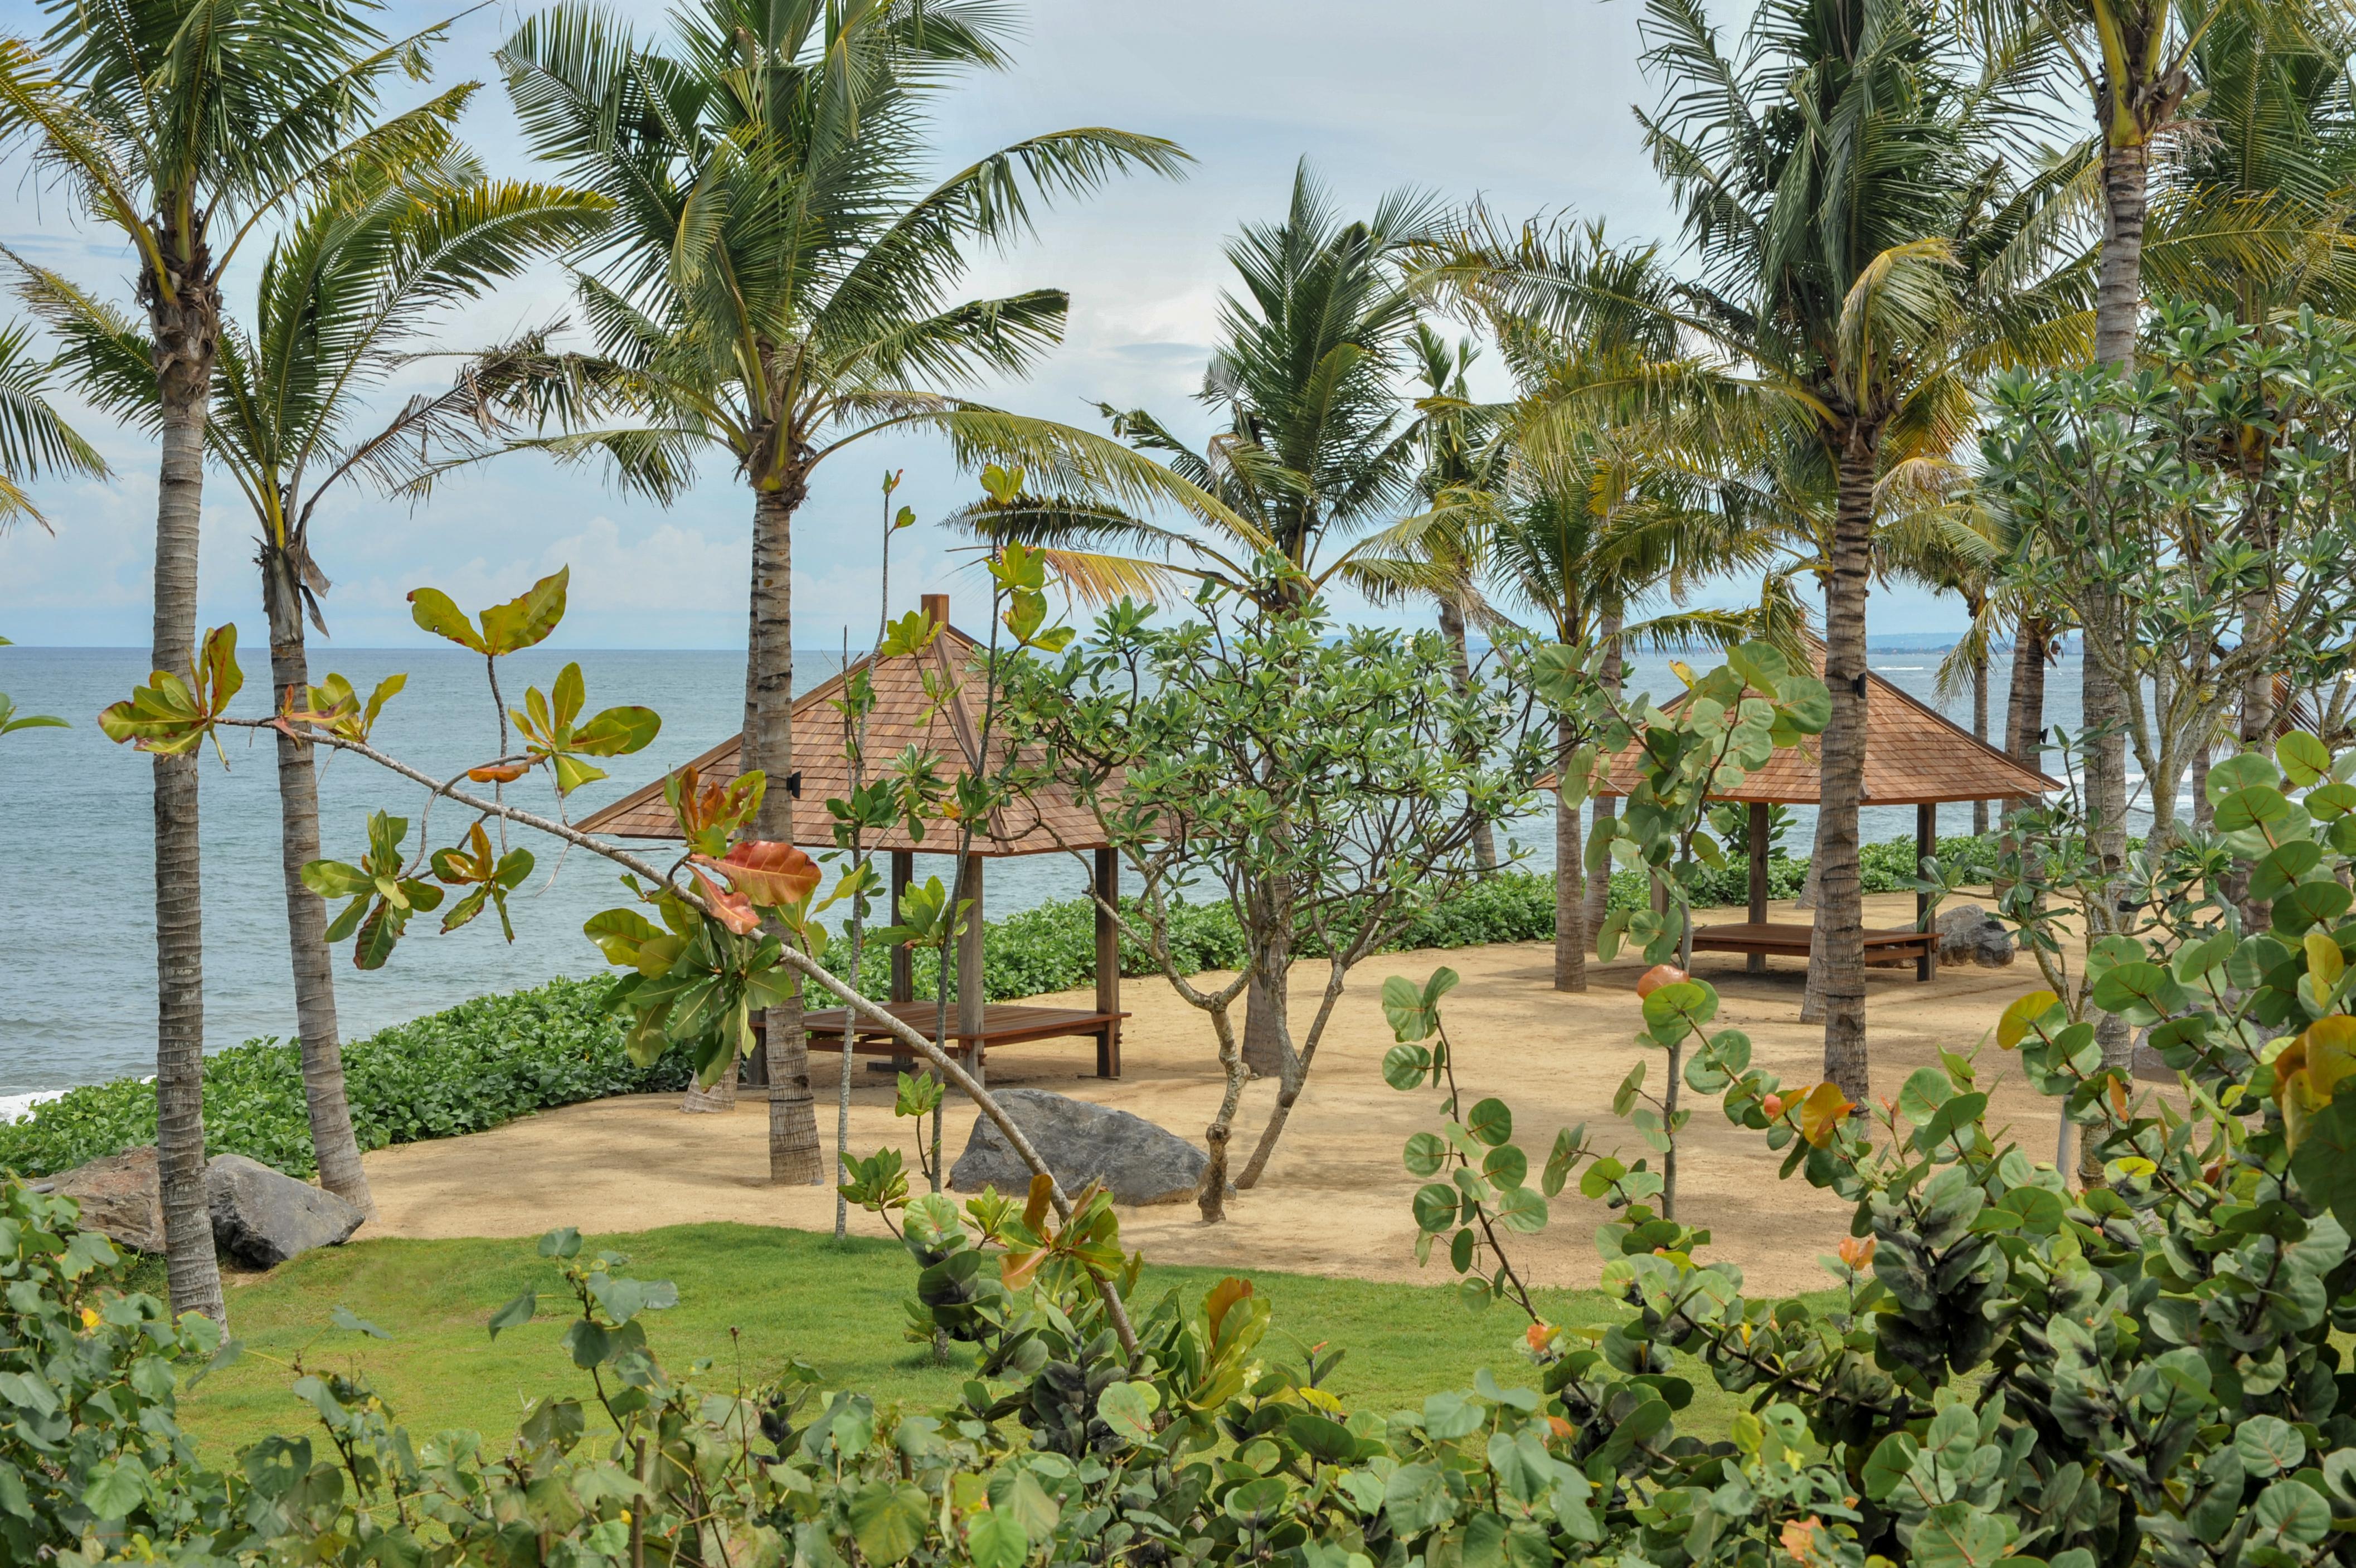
1498,0,2073,1099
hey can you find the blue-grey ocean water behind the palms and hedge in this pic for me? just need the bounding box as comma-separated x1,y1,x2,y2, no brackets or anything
0,648,2078,1094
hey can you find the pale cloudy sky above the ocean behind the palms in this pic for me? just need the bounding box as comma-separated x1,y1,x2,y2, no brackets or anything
0,0,1965,648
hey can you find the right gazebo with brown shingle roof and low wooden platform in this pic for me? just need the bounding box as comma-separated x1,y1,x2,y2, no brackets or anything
1597,644,2062,981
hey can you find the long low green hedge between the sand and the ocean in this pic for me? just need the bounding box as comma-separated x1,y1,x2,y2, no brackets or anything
0,837,1995,1177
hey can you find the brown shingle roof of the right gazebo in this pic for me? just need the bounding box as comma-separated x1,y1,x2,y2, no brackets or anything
1597,644,2062,807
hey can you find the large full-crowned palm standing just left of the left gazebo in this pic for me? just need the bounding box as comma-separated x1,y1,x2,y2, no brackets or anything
499,0,1185,1183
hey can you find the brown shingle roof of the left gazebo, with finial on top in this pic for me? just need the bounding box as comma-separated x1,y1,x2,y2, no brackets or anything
580,596,1105,856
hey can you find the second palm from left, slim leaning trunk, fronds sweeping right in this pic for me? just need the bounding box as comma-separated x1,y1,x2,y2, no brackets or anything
23,137,608,1214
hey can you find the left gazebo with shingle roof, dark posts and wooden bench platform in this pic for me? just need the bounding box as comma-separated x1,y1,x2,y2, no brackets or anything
580,594,1129,1077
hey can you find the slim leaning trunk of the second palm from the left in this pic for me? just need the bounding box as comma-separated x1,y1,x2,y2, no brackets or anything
261,545,377,1219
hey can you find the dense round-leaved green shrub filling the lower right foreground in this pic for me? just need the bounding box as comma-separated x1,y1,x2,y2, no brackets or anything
1383,734,2356,1568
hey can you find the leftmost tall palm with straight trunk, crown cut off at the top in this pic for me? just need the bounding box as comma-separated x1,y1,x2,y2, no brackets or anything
0,0,462,1321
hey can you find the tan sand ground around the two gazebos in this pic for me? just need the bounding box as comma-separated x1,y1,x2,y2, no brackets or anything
348,894,2054,1292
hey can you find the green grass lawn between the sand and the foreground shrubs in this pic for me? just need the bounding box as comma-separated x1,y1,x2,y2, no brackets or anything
153,1224,1736,1462
